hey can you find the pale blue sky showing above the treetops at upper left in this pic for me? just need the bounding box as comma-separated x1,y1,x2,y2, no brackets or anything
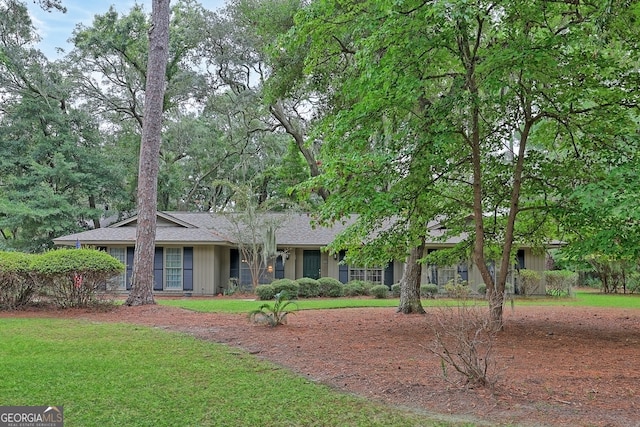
24,0,225,60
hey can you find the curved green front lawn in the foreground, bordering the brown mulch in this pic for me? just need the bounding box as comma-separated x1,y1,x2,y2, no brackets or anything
0,319,468,427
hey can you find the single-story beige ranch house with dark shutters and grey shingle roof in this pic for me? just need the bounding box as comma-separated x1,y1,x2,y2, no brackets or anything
54,212,545,296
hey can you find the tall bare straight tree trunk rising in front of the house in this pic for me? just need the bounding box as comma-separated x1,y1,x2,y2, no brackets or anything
125,0,170,305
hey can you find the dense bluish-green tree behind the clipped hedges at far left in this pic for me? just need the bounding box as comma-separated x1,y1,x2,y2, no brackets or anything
0,93,122,252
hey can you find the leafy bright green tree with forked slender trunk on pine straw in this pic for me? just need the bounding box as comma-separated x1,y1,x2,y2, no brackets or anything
290,0,638,329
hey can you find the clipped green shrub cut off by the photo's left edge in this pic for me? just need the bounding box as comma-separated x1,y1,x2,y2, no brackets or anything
0,252,36,310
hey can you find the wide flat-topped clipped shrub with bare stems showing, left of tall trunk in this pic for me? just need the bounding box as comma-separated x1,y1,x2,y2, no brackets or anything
32,249,124,308
